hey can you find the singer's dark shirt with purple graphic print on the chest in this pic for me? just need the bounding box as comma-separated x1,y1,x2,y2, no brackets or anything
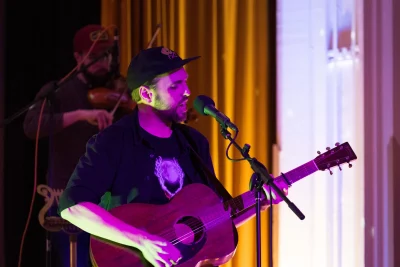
59,110,216,215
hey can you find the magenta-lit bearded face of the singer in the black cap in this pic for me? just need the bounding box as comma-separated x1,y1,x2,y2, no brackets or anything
151,68,190,122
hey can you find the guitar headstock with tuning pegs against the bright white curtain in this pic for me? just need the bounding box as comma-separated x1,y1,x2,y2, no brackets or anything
314,142,357,174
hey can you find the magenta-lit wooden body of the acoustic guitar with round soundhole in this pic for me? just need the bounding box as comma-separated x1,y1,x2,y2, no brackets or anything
90,184,238,267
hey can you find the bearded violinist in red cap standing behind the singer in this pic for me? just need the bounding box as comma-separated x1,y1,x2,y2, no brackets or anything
23,25,125,267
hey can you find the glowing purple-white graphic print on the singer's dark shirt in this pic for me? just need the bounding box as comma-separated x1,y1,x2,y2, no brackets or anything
154,157,185,199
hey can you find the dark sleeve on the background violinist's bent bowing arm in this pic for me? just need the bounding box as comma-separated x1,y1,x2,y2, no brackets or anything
23,82,63,139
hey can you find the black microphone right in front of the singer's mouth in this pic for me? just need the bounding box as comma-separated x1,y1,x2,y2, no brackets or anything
193,95,238,132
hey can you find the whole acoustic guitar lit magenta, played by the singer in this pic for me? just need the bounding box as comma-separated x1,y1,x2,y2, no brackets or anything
90,142,357,267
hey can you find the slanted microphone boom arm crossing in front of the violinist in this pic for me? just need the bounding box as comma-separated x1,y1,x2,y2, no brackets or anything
0,51,109,128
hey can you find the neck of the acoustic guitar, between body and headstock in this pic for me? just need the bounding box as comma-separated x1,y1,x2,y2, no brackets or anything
225,160,318,217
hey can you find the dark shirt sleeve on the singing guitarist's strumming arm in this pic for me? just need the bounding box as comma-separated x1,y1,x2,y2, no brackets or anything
58,125,123,213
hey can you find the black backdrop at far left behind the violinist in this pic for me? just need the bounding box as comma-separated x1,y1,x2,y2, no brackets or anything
0,0,101,267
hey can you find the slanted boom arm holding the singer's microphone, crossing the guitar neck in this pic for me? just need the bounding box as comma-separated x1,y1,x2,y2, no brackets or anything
221,129,305,220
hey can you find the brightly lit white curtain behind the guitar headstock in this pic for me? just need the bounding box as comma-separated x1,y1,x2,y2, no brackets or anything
277,0,364,267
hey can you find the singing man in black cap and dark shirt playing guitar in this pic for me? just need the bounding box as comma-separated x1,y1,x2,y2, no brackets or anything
59,47,282,266
